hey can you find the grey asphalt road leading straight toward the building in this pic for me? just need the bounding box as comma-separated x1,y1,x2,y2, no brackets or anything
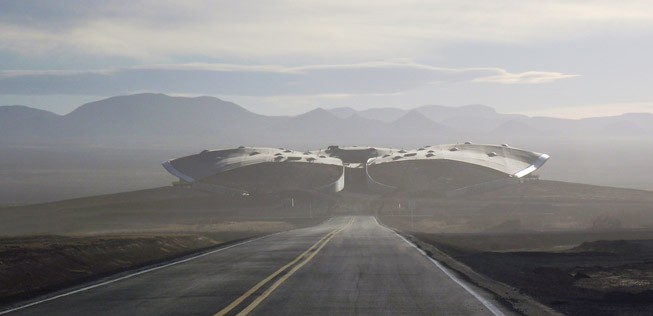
0,217,510,315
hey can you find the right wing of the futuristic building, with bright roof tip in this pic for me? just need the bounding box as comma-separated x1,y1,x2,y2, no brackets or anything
365,143,549,195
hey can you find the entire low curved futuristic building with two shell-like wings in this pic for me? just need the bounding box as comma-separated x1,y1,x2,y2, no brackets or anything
163,143,549,196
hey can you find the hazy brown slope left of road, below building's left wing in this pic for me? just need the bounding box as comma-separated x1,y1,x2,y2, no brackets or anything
0,187,333,236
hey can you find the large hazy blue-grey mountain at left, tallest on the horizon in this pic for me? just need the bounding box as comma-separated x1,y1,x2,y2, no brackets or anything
0,93,283,146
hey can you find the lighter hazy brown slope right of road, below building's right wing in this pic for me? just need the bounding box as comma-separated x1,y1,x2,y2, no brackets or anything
380,181,653,233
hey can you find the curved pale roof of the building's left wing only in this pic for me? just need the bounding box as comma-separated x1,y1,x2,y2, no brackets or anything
163,147,342,182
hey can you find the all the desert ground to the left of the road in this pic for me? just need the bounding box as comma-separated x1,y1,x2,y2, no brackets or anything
0,187,331,305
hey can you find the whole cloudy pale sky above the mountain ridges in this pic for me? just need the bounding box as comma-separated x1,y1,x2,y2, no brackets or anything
0,0,653,118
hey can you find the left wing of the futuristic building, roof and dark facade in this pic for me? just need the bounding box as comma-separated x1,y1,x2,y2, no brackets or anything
163,147,345,194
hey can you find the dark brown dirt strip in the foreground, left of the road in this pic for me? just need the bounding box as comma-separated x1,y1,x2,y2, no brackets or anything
0,230,298,305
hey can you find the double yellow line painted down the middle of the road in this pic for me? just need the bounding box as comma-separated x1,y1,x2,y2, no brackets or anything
215,218,354,316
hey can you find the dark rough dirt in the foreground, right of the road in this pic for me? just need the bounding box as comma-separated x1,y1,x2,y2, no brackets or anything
408,233,653,315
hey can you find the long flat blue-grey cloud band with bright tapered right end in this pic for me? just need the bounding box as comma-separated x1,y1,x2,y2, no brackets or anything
0,60,573,96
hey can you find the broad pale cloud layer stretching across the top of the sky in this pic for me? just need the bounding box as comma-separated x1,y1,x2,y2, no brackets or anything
0,0,653,62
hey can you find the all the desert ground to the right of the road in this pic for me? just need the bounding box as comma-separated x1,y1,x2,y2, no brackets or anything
378,181,653,315
